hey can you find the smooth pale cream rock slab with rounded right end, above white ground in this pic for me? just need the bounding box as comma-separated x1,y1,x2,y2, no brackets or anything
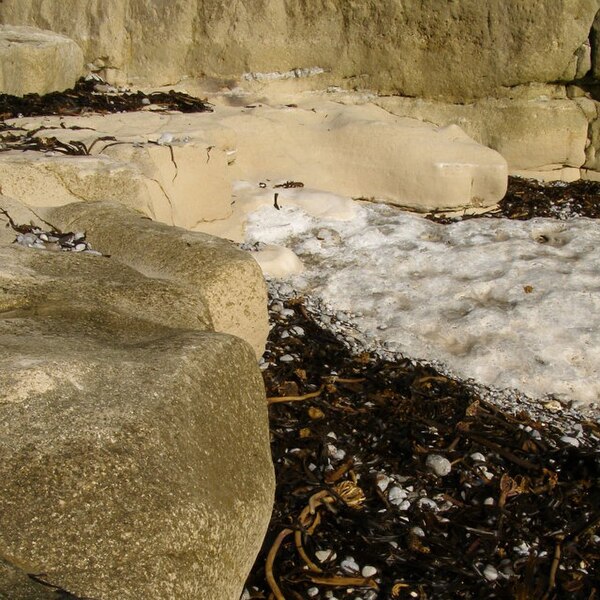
221,101,507,210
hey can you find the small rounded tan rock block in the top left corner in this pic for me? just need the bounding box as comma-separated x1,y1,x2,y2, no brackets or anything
0,25,83,96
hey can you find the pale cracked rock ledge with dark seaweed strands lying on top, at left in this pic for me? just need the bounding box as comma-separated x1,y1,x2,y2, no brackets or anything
0,111,233,229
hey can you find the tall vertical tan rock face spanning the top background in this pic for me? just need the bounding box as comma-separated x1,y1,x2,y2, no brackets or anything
0,0,599,100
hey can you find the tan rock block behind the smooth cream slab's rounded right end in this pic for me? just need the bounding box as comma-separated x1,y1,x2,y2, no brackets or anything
376,87,588,173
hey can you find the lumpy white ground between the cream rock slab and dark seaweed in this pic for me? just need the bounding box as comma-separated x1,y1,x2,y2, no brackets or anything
236,184,600,404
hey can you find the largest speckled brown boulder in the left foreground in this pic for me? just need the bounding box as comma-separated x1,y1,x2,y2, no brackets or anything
0,196,274,600
